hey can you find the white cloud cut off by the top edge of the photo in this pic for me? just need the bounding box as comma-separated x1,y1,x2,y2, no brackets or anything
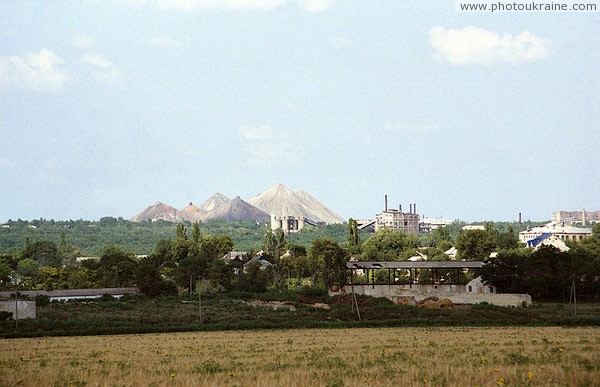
157,0,287,12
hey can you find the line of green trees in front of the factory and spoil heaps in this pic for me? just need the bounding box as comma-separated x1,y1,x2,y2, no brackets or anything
0,219,600,300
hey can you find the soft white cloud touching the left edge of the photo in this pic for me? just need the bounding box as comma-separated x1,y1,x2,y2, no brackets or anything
0,48,69,91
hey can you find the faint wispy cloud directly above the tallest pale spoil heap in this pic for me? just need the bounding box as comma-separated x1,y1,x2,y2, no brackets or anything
239,125,304,167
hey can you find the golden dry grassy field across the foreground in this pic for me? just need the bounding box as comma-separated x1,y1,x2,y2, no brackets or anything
0,327,600,386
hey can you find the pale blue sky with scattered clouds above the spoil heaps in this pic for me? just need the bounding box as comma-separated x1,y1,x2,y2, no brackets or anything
0,0,600,222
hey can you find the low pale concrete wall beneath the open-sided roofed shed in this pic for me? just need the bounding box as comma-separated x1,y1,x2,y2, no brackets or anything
330,285,531,306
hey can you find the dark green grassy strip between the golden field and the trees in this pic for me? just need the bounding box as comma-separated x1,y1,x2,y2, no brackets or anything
0,293,600,338
